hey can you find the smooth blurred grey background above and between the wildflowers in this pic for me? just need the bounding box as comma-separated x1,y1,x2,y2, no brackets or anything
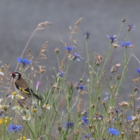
0,0,140,100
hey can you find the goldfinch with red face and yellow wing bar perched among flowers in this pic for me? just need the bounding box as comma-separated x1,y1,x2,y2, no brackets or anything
12,72,43,100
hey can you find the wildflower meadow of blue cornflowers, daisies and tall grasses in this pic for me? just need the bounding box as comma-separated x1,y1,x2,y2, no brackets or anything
0,18,140,140
